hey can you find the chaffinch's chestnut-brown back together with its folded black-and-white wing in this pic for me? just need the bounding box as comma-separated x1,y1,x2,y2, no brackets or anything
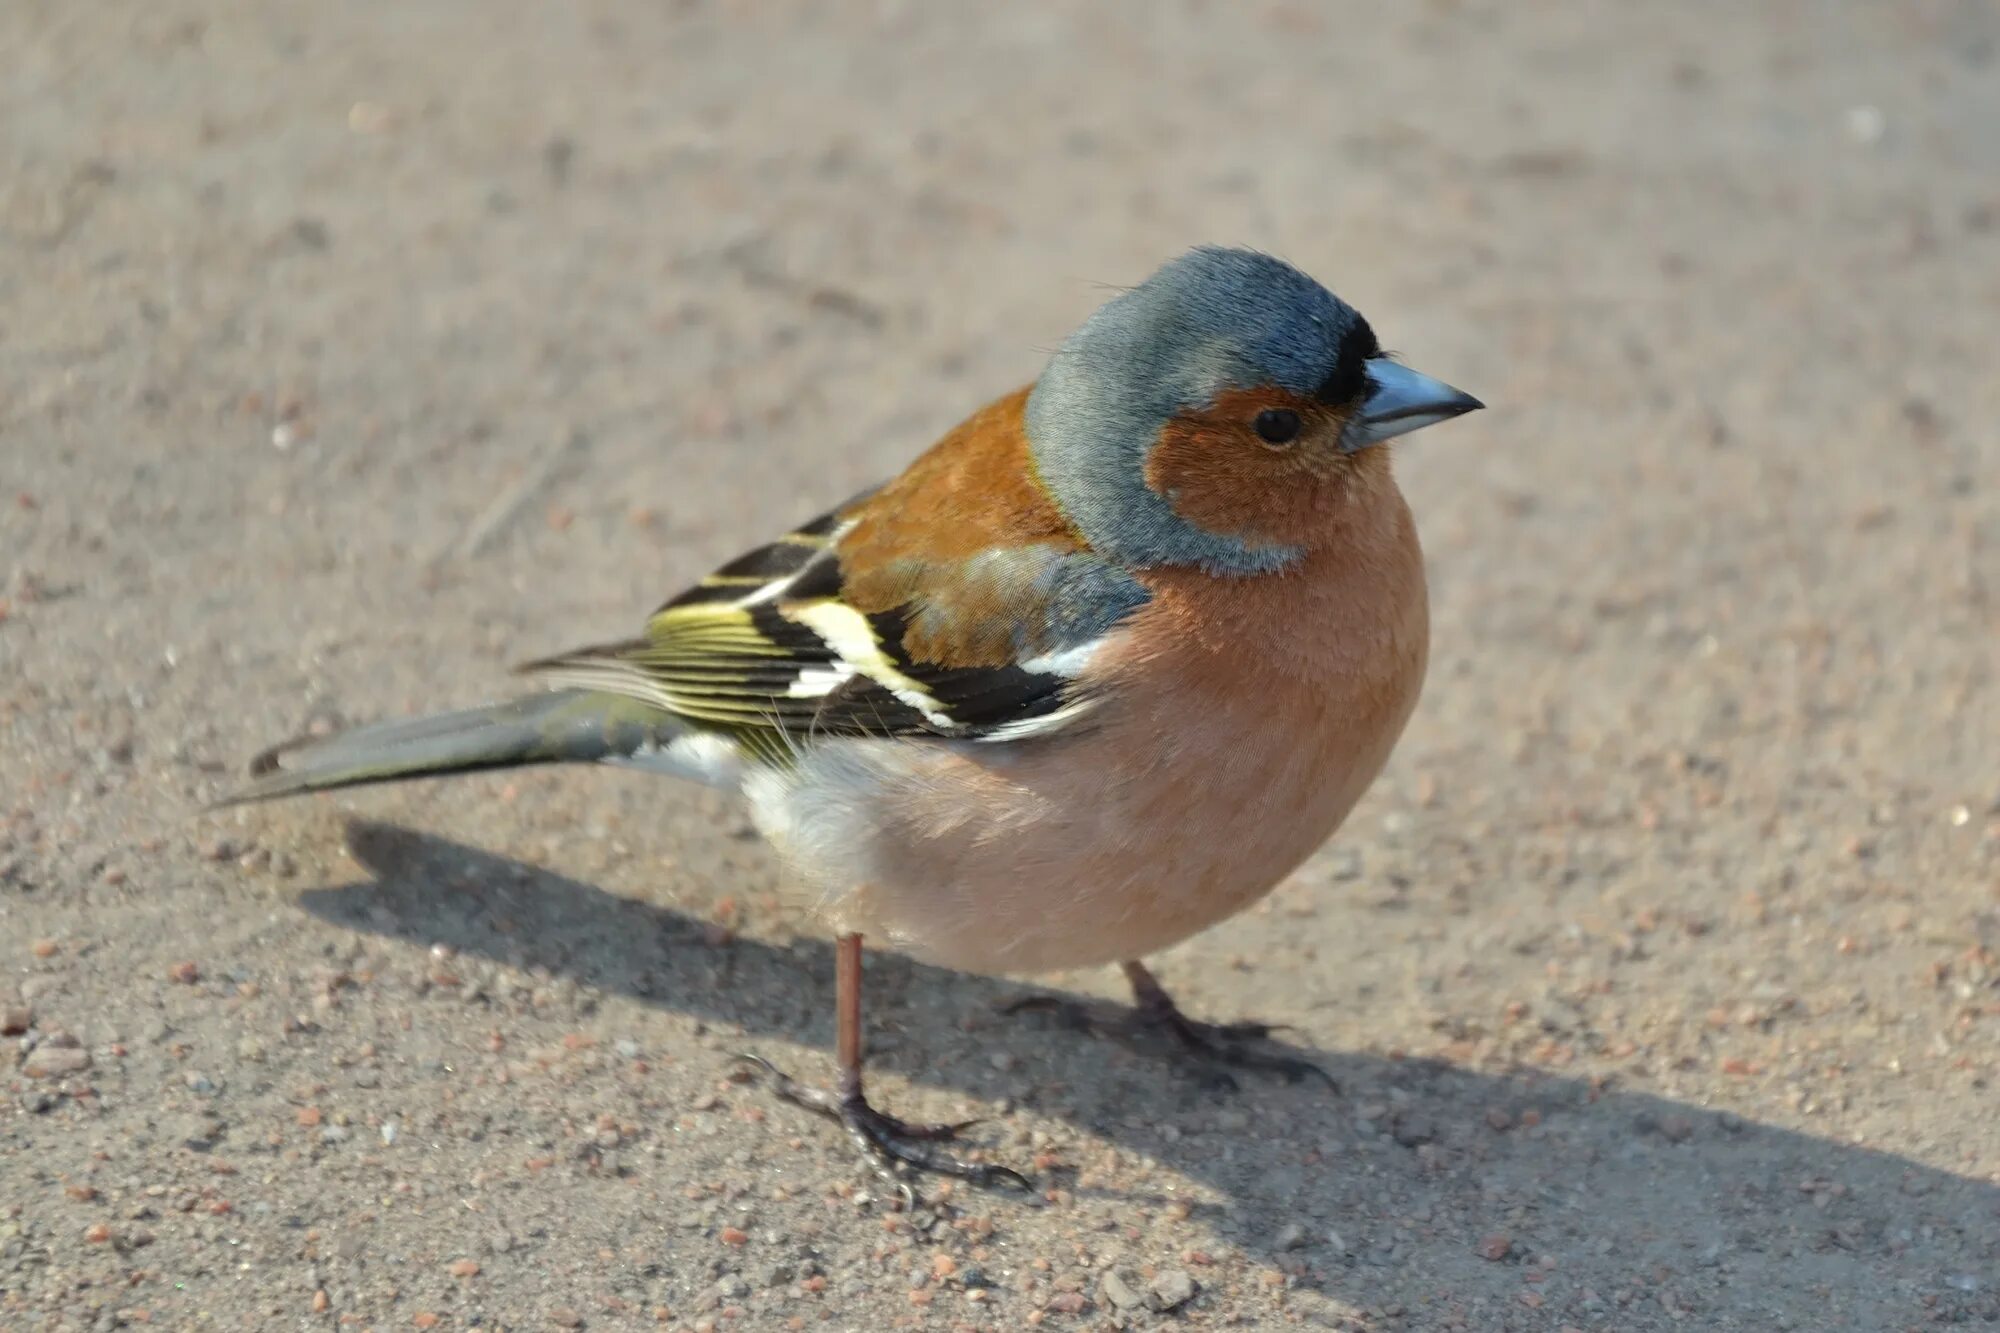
524,390,1146,757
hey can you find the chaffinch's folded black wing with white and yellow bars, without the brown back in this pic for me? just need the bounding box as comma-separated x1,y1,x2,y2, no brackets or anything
524,496,1144,753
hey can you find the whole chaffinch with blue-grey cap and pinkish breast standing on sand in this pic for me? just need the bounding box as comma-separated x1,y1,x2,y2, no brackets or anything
218,246,1484,1205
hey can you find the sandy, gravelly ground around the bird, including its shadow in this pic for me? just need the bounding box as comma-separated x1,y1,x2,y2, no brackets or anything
0,0,2000,1331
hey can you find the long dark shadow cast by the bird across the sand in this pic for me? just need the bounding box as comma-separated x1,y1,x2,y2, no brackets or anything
302,821,2000,1327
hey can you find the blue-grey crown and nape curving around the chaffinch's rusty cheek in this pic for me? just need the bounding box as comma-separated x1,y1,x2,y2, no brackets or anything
1026,246,1374,574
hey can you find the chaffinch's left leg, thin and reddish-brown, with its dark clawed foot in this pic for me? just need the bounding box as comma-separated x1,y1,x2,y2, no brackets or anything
740,935,1034,1209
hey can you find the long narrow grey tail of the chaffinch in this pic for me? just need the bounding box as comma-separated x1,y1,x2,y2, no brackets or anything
216,691,686,807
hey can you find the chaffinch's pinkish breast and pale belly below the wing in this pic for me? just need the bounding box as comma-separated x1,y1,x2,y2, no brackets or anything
768,472,1428,973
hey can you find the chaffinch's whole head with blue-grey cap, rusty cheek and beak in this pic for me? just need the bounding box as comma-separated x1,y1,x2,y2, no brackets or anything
1026,246,1480,574
